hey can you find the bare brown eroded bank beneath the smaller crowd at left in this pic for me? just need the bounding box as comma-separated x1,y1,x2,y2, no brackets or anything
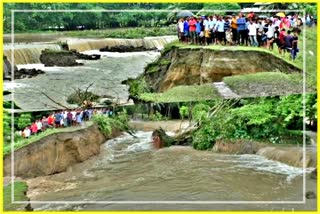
4,125,120,178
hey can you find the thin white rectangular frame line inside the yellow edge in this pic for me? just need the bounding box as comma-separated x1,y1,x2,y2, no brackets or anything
11,9,306,204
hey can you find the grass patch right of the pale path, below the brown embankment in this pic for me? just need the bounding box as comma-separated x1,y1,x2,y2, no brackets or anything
223,72,303,97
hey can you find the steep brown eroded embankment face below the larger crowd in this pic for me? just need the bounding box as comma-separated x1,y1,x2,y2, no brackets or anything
139,47,301,92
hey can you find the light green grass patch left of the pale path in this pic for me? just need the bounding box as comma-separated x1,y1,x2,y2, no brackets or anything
140,84,221,103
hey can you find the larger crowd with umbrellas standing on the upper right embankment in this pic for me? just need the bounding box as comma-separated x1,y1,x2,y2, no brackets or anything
177,12,313,60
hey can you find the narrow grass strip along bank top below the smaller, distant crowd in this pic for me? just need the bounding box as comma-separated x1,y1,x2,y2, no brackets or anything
3,121,93,155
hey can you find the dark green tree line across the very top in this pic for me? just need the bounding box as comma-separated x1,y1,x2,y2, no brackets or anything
3,3,316,33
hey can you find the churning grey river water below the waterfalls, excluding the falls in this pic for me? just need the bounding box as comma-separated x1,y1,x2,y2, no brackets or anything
4,51,159,111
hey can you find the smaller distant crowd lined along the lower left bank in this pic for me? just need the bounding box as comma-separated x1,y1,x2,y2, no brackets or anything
18,108,113,138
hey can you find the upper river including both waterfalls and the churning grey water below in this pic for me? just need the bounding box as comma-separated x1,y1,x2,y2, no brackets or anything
4,36,176,111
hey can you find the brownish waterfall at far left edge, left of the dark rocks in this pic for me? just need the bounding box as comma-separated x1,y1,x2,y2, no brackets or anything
4,44,61,65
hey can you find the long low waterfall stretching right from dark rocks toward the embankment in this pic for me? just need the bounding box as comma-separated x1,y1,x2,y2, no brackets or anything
67,36,177,52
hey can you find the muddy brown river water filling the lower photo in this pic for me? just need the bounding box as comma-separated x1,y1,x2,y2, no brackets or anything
27,131,316,210
